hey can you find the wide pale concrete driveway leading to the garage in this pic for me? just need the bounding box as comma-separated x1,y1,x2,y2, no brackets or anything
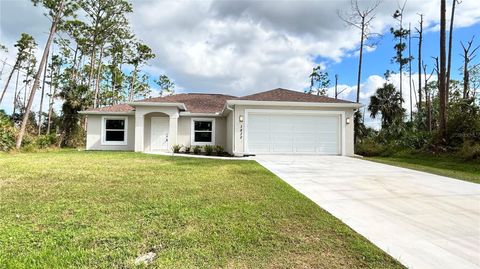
255,156,480,269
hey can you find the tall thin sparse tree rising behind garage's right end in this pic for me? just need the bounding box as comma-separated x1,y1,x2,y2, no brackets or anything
338,0,380,103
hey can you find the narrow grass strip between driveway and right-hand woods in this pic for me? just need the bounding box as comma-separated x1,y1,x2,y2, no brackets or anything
365,154,480,183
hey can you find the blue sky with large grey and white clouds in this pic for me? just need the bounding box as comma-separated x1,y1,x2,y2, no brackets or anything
0,0,480,127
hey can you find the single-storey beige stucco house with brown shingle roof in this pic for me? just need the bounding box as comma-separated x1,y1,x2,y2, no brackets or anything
81,89,362,156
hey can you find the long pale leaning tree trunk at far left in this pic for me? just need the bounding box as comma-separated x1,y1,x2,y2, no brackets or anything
16,0,65,149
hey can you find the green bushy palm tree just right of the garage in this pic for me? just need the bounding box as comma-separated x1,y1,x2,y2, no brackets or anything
368,83,405,129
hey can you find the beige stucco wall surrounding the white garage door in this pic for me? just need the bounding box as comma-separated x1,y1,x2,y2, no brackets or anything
233,105,354,156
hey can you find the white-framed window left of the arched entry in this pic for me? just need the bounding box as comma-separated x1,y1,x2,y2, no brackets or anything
102,117,128,145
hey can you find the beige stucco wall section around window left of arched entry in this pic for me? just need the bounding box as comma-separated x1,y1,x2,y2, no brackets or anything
86,115,135,150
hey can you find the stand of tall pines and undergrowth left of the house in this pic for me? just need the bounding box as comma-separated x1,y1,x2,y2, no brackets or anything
0,0,174,149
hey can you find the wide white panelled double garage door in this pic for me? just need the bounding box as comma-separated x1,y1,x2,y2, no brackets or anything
246,113,341,155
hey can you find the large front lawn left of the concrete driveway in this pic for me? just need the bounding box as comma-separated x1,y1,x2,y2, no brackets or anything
0,150,402,268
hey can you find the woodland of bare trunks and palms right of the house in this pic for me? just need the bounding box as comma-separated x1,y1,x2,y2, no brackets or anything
307,0,480,159
